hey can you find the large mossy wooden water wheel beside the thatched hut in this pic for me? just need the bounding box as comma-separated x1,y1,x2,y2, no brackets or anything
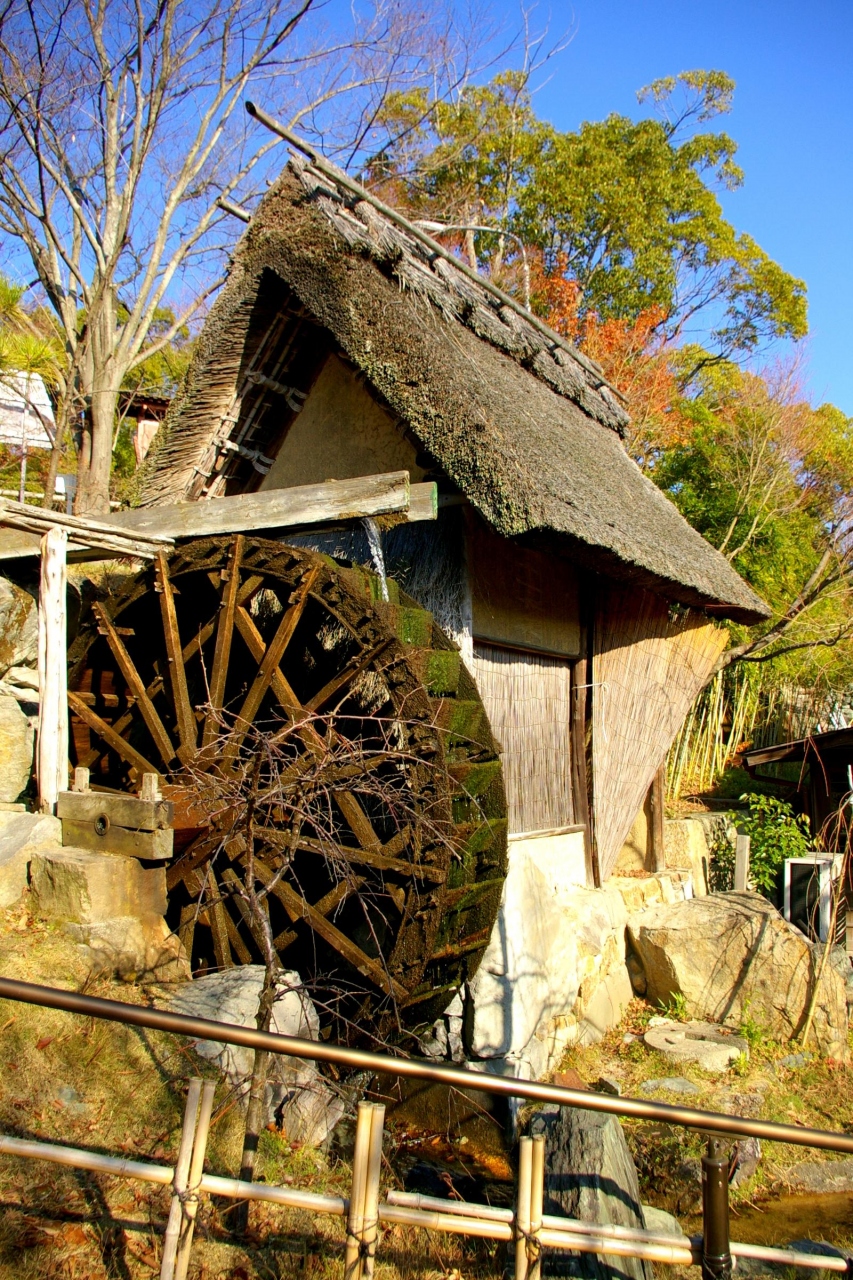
69,536,506,1039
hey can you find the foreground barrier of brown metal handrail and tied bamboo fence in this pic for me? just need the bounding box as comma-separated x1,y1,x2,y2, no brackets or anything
0,978,853,1280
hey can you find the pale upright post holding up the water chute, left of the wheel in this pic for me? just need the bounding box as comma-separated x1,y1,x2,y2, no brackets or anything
36,529,68,813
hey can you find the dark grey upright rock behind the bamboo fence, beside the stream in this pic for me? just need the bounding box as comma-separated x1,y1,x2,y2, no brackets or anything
530,1106,652,1280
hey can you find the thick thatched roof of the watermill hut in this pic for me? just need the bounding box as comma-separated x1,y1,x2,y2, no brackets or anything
141,152,767,621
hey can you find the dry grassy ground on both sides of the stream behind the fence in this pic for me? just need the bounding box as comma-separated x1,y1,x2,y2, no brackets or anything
0,905,853,1280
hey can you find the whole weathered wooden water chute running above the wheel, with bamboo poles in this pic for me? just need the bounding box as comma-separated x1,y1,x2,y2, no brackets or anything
0,471,438,559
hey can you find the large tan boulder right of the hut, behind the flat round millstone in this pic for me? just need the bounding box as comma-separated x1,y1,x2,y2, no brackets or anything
628,893,847,1057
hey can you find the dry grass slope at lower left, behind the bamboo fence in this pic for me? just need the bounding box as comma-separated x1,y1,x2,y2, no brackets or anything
0,905,501,1280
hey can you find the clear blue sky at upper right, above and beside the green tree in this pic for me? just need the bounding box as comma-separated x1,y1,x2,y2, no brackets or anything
484,0,853,416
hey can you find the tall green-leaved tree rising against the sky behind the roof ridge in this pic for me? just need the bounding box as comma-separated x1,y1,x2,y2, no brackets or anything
370,72,807,362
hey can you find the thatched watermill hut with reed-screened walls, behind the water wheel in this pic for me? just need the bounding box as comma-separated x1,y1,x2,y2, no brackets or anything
141,149,767,884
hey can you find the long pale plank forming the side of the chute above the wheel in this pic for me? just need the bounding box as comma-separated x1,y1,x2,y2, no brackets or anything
104,471,417,538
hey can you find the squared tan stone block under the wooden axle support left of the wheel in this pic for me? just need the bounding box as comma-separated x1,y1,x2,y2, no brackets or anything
29,847,167,924
